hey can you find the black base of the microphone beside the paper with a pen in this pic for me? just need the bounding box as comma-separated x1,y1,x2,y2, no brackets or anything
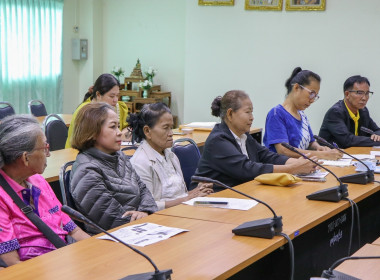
232,217,282,239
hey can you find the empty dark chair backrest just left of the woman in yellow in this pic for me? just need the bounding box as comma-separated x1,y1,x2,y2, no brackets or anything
43,114,68,151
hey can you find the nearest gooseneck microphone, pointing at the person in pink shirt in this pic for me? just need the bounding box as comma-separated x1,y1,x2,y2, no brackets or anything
61,205,173,280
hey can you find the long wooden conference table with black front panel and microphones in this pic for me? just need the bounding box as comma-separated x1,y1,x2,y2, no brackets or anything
0,148,380,279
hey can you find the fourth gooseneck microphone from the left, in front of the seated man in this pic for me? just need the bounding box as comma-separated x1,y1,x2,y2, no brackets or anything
314,135,375,185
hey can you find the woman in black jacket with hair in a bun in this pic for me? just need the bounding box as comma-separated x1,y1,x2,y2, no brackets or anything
196,90,315,191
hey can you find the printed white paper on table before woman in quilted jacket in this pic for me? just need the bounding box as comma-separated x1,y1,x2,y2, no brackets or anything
98,223,188,247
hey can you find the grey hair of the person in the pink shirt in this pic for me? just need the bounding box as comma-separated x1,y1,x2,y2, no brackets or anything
0,115,42,168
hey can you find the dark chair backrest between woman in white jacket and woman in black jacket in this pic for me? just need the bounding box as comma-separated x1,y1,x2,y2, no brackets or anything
172,138,201,190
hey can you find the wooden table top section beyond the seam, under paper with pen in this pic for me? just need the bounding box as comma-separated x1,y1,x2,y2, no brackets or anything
157,148,380,237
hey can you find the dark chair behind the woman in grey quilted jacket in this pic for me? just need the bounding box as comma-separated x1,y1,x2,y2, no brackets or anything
59,161,84,229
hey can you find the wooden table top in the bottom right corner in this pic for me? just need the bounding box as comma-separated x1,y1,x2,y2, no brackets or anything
334,244,380,280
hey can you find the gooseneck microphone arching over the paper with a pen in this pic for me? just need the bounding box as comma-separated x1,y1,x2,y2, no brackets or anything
191,176,282,239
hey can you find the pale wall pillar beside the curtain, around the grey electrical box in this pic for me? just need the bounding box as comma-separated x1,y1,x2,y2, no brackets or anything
63,0,104,113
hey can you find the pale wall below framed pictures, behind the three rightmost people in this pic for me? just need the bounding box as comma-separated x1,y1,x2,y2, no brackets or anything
184,0,380,133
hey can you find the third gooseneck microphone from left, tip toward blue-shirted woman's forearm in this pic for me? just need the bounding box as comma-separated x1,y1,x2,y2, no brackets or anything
281,142,348,202
